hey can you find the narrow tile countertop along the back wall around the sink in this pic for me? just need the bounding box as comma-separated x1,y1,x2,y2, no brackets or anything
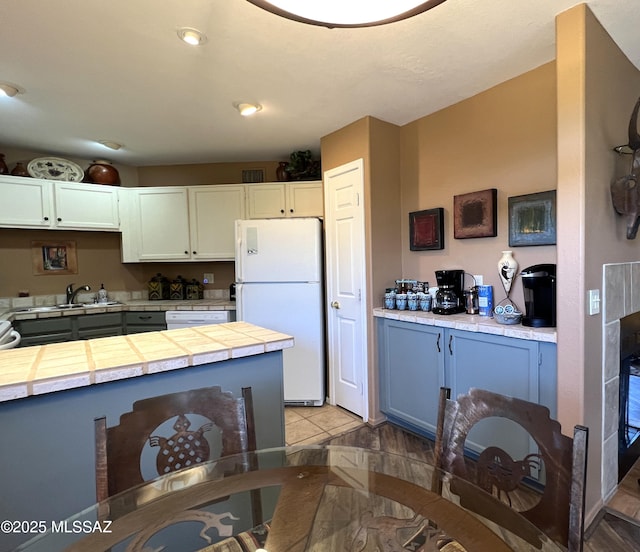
0,299,236,321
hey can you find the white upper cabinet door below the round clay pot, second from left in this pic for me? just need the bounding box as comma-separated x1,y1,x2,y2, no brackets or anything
54,182,120,232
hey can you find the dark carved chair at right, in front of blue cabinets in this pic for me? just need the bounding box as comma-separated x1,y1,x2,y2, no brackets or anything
434,387,588,552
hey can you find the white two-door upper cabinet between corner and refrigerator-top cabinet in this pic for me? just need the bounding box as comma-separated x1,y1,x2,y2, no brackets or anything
121,185,245,262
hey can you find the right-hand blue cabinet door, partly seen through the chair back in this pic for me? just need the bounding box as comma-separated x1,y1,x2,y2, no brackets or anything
445,330,539,468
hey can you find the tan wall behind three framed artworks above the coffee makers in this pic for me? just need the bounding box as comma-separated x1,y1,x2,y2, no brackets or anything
401,63,556,302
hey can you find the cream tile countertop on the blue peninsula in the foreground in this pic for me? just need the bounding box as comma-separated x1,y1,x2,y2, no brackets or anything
0,322,294,402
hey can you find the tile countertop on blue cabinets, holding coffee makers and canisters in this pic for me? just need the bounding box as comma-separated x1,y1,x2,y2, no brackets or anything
373,308,557,343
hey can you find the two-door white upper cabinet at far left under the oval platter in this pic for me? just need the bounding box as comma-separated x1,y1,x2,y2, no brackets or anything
0,175,120,232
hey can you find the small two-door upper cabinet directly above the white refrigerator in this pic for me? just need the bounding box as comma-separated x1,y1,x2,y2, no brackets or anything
247,181,324,219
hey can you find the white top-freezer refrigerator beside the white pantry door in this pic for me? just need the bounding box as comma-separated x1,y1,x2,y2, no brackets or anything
236,218,326,406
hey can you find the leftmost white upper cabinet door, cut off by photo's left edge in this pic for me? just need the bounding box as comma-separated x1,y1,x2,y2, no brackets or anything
0,176,54,228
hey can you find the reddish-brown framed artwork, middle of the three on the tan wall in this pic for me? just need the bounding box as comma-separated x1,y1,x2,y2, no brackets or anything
453,188,498,239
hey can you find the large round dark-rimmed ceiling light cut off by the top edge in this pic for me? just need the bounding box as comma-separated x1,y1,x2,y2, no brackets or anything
247,0,446,29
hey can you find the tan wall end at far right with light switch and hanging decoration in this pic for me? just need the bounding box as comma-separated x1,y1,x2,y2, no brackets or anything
557,5,640,515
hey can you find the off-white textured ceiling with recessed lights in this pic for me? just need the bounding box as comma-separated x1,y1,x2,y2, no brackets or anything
0,0,640,166
